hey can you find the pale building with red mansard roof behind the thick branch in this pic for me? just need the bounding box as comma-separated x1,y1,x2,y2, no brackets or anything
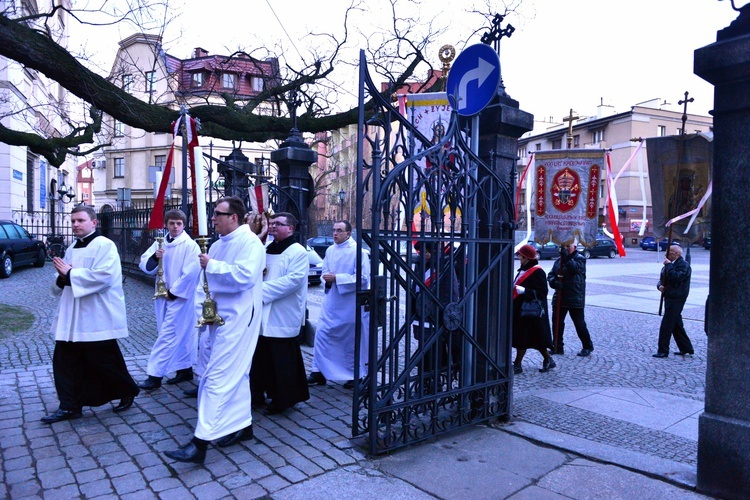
94,33,278,210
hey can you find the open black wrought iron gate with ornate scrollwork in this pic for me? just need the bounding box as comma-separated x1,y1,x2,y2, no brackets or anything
352,54,513,453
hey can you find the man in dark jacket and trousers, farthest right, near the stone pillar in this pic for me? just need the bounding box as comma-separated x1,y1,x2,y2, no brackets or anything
654,245,693,358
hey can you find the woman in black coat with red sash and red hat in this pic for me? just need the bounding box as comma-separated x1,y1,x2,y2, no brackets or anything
513,245,556,375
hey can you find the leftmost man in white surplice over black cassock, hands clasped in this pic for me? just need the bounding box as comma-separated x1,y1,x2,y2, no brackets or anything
42,205,139,424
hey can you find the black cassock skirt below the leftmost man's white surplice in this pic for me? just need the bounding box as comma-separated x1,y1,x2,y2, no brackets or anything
52,339,139,410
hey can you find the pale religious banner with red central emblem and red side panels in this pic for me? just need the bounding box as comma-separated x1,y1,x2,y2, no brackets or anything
533,149,605,246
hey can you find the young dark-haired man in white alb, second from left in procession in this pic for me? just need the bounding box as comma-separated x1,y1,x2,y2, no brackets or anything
138,209,201,391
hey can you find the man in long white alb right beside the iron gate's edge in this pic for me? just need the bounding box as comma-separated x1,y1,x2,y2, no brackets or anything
307,221,370,389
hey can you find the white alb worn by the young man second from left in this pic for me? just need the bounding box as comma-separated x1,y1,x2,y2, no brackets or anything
139,231,201,377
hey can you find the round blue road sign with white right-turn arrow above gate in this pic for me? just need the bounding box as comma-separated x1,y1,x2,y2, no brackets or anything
446,43,500,116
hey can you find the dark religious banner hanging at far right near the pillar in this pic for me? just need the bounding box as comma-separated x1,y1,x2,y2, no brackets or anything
646,134,713,242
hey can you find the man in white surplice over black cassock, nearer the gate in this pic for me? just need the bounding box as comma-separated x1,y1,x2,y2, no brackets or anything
250,212,310,415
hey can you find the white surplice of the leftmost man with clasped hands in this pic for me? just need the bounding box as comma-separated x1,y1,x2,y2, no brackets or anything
52,236,128,342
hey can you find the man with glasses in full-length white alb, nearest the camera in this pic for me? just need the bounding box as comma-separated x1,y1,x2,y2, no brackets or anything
165,196,266,463
